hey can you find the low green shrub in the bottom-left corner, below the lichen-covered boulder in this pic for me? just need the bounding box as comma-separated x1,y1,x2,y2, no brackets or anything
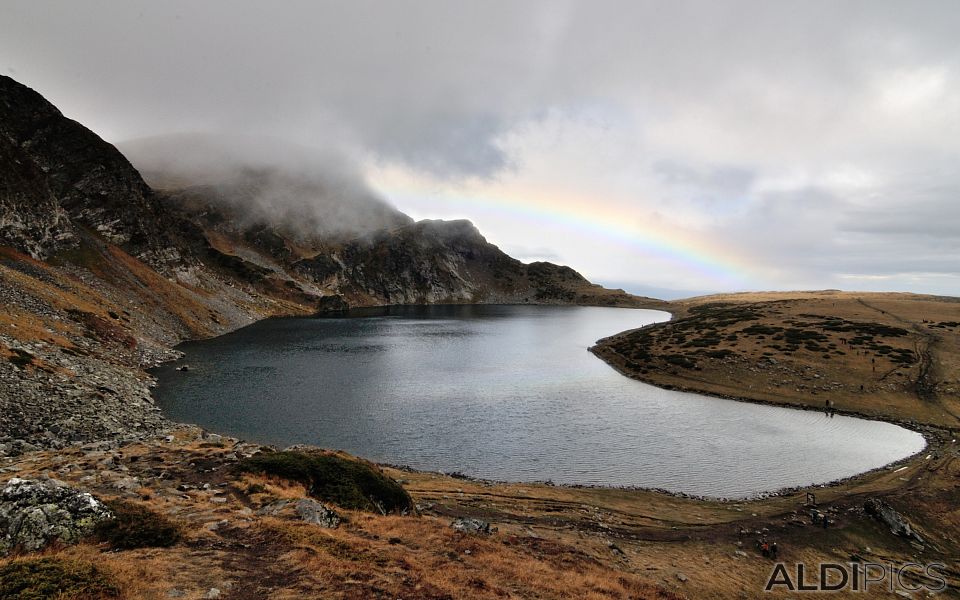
0,557,120,600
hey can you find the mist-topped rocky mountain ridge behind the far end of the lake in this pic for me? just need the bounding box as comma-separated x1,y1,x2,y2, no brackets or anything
126,136,649,309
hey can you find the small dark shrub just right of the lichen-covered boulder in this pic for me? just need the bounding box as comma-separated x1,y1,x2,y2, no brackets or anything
94,500,180,550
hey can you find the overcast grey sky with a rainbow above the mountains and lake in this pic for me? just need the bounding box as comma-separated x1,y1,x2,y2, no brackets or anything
0,0,960,295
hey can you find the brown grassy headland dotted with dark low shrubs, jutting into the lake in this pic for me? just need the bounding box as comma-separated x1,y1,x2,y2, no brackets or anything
594,290,960,427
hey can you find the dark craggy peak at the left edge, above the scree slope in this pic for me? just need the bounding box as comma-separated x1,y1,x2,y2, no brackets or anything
0,76,171,258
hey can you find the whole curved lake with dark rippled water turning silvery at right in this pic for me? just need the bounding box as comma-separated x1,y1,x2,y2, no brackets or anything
155,306,924,497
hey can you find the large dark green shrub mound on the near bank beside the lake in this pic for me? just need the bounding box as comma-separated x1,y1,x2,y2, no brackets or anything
239,451,413,513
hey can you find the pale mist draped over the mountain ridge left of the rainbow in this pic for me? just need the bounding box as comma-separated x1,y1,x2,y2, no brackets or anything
118,133,413,242
